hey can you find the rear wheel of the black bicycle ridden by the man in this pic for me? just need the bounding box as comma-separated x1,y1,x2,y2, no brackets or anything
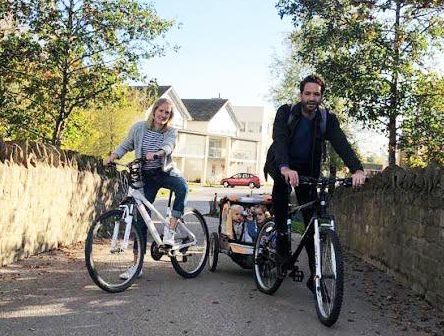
254,222,283,294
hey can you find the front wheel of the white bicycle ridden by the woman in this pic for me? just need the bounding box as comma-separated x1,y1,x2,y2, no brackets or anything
85,210,143,293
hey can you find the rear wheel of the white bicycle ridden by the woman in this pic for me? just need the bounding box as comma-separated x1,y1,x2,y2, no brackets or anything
171,209,209,278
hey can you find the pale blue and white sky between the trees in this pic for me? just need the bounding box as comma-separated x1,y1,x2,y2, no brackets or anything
142,0,292,106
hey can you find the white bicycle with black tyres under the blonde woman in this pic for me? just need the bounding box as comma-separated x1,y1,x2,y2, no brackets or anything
85,159,209,293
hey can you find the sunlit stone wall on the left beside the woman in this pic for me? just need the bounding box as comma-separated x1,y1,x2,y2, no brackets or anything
0,142,123,266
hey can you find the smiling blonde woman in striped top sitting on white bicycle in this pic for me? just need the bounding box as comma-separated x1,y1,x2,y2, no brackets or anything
106,98,188,276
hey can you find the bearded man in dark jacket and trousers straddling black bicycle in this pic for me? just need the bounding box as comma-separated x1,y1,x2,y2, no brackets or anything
264,75,365,292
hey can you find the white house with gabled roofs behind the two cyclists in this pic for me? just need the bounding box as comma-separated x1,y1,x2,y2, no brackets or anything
138,86,271,184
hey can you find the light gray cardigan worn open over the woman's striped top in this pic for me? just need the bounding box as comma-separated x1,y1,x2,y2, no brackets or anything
113,121,180,176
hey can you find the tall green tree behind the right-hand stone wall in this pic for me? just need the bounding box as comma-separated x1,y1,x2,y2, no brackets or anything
276,0,444,165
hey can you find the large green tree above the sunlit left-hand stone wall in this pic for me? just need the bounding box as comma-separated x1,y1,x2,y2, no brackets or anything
0,0,173,146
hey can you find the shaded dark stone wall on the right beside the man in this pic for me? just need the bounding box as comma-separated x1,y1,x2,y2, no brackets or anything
332,167,444,307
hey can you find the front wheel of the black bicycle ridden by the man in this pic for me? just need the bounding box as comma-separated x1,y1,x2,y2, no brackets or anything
315,228,344,327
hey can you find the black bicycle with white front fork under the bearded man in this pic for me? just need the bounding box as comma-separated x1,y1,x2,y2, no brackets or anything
254,176,352,327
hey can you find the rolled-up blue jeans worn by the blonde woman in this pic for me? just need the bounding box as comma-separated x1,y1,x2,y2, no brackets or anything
138,168,188,252
